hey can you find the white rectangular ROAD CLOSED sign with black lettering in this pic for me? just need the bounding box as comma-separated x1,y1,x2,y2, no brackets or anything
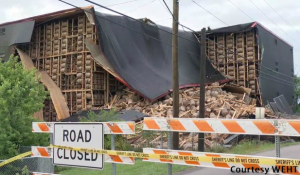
53,123,104,169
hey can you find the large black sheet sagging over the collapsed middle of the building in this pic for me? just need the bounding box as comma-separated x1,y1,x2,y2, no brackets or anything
95,12,225,100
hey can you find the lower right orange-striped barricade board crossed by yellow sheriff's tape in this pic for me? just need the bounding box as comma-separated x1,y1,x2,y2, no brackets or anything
143,148,300,174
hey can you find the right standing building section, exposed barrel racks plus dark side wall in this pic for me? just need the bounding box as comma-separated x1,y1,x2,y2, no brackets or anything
207,22,294,106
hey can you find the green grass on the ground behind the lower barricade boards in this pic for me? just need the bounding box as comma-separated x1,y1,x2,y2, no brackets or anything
55,142,299,175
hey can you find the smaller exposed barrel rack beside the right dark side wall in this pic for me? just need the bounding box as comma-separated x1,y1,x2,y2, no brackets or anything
206,30,260,95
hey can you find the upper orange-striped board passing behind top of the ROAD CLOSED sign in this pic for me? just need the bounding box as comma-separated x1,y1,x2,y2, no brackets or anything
32,122,135,134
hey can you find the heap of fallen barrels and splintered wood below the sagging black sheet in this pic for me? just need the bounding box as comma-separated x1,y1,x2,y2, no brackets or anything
101,83,272,150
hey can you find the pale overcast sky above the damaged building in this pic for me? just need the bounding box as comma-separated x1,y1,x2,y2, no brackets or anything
0,0,300,75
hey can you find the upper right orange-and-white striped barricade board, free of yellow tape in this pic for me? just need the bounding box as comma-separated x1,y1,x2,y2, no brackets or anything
143,117,300,137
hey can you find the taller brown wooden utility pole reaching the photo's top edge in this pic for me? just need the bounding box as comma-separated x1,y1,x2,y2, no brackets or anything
172,0,179,150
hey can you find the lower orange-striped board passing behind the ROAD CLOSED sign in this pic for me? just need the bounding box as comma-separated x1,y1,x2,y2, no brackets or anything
31,146,135,165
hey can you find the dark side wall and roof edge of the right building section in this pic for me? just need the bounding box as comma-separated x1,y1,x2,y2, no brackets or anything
210,22,294,105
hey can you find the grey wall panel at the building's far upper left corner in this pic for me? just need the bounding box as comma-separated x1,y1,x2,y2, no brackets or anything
0,21,34,60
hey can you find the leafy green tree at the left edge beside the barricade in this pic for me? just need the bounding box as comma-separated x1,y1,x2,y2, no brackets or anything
0,56,49,159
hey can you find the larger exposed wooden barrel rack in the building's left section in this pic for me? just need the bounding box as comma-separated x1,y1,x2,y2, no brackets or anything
18,12,121,121
